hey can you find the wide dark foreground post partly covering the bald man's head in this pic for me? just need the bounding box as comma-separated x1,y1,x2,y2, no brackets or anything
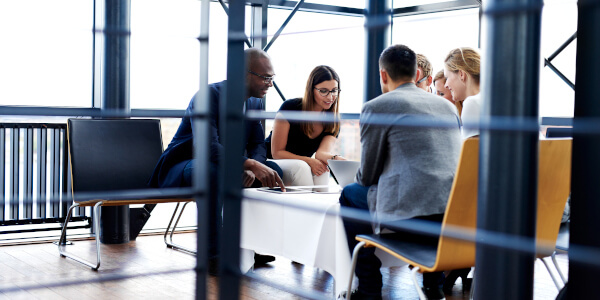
218,0,246,299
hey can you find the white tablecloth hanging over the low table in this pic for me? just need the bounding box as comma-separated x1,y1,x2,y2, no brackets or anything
241,189,404,295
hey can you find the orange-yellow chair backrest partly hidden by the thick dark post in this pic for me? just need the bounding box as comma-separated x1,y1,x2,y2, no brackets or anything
432,138,572,270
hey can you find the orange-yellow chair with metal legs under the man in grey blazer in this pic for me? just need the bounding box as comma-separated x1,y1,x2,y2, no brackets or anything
347,138,571,299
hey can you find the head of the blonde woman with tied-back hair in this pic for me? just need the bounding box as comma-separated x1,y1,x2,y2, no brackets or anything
444,47,481,104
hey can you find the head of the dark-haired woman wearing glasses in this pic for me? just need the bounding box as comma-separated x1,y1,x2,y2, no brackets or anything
302,66,342,136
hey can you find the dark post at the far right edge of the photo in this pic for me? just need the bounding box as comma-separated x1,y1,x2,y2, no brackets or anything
567,0,600,299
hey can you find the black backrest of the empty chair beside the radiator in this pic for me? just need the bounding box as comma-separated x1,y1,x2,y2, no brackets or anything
67,119,162,201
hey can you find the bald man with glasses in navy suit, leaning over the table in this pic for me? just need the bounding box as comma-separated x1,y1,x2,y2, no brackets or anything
148,48,285,271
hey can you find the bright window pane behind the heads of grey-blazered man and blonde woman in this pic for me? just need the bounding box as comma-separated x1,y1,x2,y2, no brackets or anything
392,8,479,81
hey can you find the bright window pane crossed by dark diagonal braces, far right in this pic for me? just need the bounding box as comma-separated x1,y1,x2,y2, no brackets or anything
540,0,577,117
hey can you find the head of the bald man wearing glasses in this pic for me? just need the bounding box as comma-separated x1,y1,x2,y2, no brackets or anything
244,48,275,98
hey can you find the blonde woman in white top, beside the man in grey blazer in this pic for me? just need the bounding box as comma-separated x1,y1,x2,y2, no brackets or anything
444,47,482,139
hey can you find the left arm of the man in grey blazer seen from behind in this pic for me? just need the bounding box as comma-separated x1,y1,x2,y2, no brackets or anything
356,105,389,186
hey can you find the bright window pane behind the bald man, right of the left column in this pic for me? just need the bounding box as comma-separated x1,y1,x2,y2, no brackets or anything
130,0,237,109
